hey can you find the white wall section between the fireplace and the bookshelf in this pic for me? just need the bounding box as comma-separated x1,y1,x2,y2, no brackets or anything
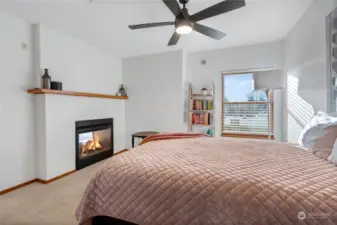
123,51,186,147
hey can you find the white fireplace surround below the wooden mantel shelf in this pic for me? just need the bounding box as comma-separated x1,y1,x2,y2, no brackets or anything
35,95,125,180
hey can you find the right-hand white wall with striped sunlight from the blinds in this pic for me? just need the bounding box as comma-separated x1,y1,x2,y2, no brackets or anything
283,0,337,142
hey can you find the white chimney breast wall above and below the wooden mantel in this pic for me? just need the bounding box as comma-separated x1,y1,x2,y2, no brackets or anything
37,26,125,179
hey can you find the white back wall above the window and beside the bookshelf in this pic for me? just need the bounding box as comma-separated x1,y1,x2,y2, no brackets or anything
185,42,282,136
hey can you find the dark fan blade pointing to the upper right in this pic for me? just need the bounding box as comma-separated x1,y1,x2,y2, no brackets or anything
191,0,246,22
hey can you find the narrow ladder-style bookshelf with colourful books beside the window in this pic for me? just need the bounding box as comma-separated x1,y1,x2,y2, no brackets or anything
188,83,215,136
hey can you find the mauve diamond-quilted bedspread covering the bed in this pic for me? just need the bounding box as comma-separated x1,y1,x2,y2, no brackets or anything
76,138,337,225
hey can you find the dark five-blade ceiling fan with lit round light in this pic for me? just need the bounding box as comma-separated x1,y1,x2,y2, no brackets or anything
129,0,246,46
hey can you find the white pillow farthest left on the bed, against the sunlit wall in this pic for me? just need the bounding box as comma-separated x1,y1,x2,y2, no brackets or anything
298,111,337,148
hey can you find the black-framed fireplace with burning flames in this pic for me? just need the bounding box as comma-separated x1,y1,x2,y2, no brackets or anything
75,118,114,170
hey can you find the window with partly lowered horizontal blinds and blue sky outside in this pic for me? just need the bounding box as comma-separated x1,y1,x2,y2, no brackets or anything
222,73,273,138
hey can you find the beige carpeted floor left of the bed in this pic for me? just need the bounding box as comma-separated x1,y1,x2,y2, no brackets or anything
0,163,101,225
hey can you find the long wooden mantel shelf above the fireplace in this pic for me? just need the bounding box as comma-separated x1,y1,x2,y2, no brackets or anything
28,88,129,100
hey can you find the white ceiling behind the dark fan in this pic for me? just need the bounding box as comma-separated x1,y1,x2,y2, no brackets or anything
0,0,314,57
